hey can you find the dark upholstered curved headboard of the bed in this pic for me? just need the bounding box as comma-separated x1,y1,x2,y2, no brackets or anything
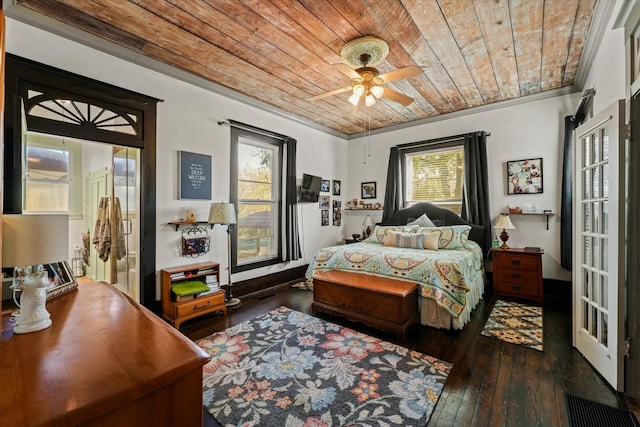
384,202,490,254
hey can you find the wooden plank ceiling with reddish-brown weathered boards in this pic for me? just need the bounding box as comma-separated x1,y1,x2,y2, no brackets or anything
17,0,597,135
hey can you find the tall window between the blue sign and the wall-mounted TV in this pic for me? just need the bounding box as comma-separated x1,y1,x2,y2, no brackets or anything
231,127,282,271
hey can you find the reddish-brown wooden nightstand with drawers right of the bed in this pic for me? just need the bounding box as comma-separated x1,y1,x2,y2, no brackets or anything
491,248,544,304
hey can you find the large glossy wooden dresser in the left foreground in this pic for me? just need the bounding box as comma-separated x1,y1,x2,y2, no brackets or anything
0,282,209,427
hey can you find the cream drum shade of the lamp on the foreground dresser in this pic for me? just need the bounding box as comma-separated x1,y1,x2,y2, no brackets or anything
2,215,69,267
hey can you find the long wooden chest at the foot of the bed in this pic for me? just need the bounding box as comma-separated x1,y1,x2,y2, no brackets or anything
312,270,418,339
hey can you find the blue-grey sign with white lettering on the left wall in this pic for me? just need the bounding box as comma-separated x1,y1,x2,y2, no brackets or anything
178,151,211,200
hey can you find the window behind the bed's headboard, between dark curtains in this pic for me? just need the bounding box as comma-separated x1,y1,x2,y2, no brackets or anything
402,141,464,215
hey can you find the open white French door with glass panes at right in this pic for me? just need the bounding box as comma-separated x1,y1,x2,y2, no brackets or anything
573,100,626,391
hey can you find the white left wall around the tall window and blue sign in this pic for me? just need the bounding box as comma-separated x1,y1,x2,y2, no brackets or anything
6,18,348,297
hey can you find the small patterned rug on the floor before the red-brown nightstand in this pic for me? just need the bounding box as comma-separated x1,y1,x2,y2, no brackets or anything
481,300,543,351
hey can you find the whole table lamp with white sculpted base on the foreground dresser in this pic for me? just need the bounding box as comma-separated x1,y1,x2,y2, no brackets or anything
2,215,69,334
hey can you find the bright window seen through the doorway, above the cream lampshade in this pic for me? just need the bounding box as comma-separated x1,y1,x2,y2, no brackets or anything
23,133,82,218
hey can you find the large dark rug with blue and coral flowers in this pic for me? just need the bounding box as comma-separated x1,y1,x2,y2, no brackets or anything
197,307,453,427
